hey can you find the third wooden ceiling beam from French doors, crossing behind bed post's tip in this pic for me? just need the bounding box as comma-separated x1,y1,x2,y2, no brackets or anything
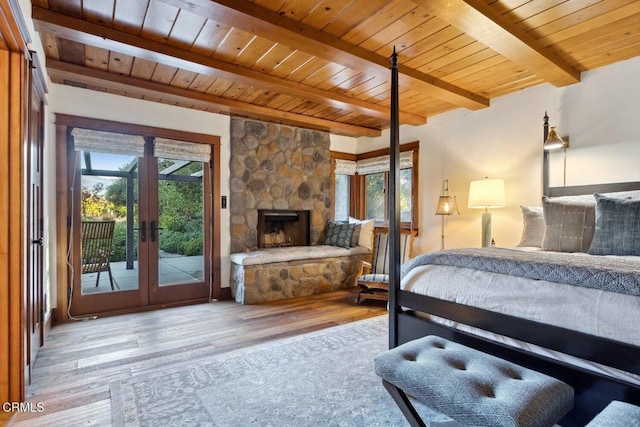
160,0,489,110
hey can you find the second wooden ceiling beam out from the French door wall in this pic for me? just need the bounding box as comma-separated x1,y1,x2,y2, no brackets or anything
32,7,427,125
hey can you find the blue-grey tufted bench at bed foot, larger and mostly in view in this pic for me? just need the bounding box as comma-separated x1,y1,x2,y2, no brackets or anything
375,336,573,426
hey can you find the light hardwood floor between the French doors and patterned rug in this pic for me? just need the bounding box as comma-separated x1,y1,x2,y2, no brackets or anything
13,288,386,427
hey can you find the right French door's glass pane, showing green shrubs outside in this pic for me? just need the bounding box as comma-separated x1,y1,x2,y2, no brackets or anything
156,158,205,287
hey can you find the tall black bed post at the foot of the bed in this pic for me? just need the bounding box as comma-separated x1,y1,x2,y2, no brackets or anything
388,46,400,348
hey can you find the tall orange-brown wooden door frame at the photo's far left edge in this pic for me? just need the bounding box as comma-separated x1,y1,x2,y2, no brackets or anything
0,46,27,412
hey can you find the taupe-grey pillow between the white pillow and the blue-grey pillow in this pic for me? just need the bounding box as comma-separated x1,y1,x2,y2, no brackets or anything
542,196,595,252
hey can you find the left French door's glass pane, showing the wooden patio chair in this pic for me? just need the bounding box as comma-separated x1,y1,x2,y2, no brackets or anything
76,152,139,295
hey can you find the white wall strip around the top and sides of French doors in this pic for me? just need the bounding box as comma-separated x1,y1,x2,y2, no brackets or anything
45,84,230,303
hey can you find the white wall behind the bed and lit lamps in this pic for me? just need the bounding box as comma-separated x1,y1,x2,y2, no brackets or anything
357,58,640,253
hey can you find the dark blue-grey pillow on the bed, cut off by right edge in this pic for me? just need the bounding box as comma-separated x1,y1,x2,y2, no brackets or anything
589,194,640,255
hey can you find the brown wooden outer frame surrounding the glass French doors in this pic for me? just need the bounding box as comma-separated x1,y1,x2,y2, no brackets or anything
55,114,221,322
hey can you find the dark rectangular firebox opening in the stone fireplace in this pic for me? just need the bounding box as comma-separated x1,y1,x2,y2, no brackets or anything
258,209,310,248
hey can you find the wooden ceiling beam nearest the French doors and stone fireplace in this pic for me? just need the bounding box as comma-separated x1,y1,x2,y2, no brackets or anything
47,59,381,137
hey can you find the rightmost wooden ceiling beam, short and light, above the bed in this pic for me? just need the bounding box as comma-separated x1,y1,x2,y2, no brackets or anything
413,0,580,87
